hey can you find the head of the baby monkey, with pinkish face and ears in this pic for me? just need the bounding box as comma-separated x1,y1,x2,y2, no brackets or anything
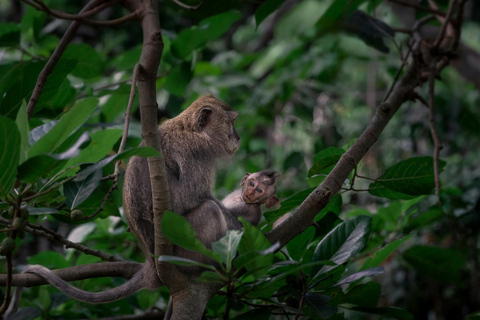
241,171,278,208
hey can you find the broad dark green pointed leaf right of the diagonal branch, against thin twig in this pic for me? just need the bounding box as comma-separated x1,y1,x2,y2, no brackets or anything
376,157,446,196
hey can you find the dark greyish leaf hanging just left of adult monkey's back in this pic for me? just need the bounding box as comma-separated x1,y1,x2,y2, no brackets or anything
63,166,103,209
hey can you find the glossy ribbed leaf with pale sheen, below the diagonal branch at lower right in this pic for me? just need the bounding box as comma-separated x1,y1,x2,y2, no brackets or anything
312,216,372,278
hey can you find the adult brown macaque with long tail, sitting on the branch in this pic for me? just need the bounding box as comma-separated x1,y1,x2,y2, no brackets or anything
5,95,242,314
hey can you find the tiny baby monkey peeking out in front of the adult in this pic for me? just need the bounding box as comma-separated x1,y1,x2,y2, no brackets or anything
222,170,278,226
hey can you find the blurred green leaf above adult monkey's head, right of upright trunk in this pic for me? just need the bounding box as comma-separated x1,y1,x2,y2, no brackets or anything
172,12,242,59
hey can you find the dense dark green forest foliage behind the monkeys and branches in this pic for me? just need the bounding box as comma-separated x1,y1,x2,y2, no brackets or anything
0,0,480,319
